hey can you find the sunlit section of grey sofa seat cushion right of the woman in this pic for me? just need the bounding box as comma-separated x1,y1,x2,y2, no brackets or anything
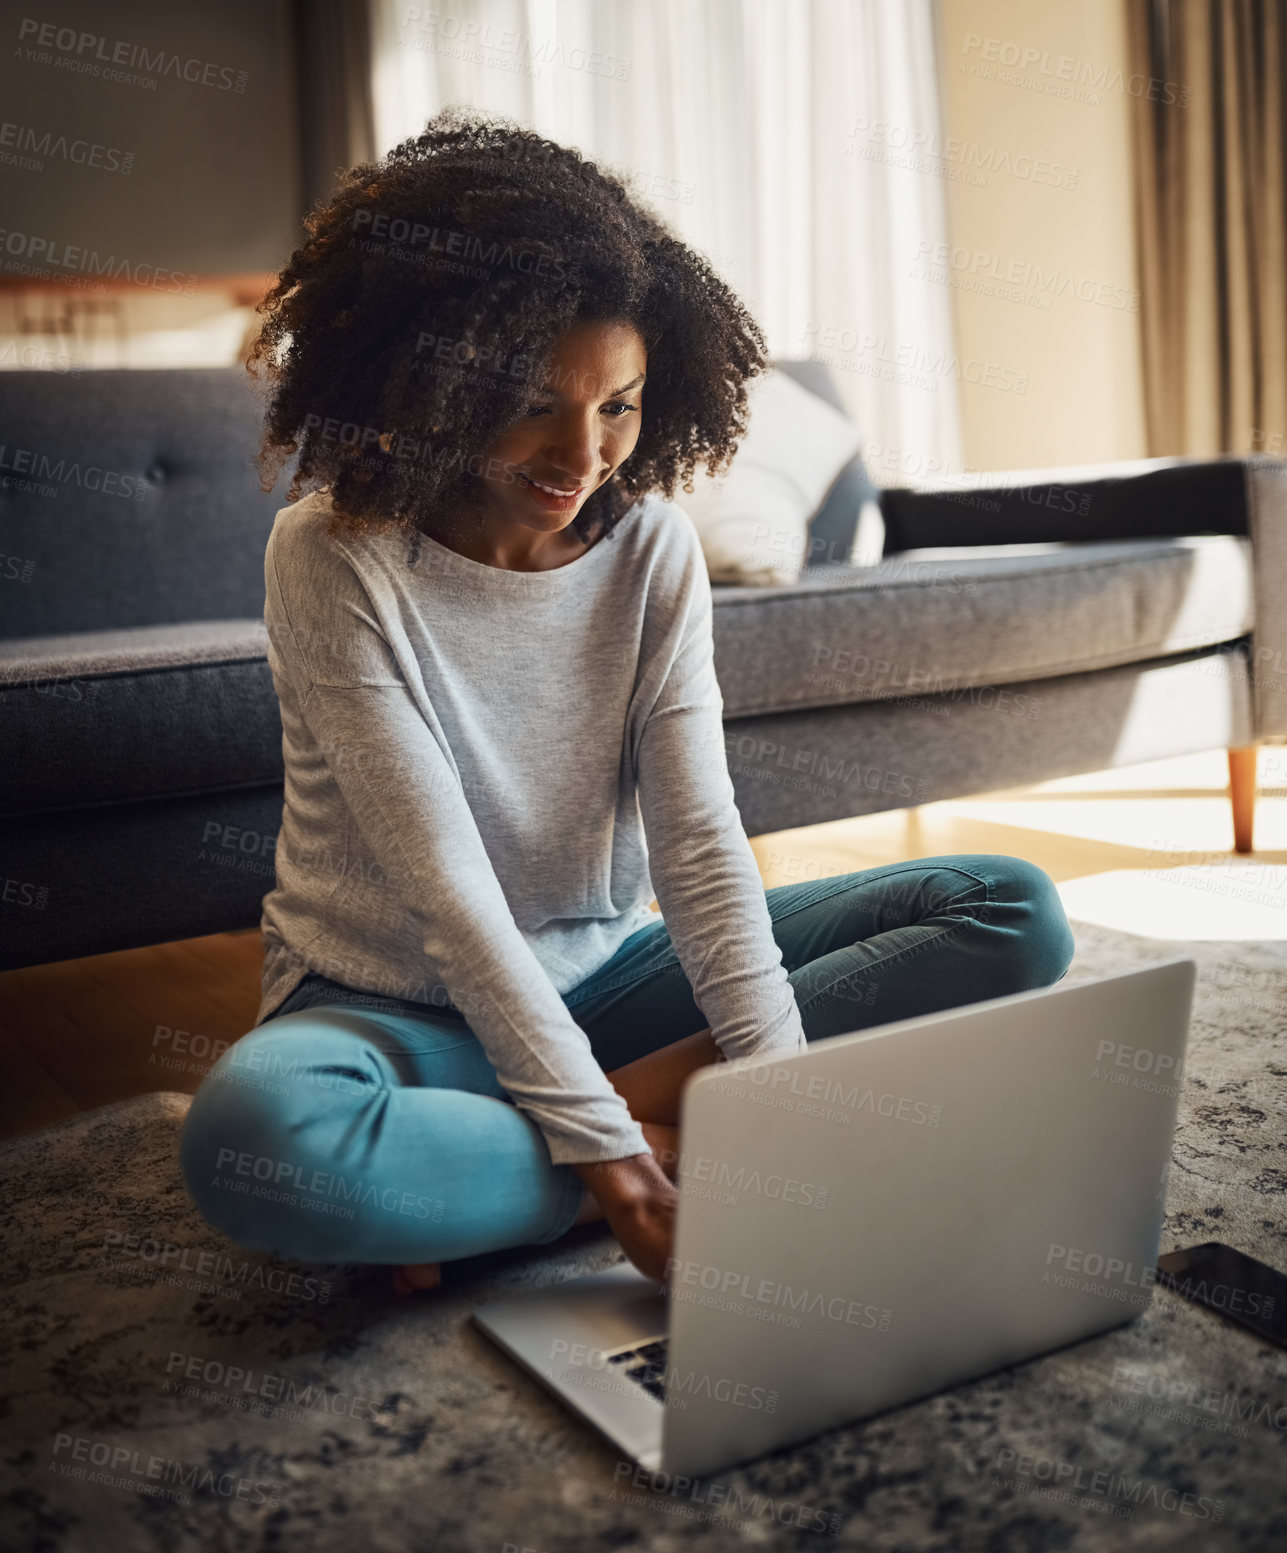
711,534,1254,717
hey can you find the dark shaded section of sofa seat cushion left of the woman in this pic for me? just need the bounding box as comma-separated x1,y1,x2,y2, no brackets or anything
0,620,283,815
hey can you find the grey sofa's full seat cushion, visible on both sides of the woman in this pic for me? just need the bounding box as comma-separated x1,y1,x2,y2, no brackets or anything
0,534,1253,815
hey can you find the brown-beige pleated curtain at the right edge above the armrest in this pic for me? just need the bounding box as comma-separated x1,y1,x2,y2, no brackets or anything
1126,0,1287,457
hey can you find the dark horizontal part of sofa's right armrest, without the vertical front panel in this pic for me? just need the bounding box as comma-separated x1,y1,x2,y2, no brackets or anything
880,458,1248,554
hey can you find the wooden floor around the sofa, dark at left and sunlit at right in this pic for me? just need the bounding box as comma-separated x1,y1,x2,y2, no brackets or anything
0,745,1287,1137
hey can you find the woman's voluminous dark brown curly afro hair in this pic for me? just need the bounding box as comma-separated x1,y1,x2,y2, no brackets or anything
245,107,768,548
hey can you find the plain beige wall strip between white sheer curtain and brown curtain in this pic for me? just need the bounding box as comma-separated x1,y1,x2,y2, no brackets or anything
921,0,1146,469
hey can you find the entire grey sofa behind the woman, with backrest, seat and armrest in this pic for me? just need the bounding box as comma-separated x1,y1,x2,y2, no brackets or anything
0,362,1287,968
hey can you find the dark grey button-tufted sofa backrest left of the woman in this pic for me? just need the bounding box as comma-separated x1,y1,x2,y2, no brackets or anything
0,367,280,637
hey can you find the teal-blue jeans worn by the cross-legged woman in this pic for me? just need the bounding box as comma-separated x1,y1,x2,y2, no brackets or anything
180,854,1074,1263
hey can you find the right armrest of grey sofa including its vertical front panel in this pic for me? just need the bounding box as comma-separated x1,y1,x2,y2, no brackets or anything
880,455,1287,738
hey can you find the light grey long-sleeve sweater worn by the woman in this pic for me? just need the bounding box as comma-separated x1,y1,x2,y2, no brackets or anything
256,492,804,1165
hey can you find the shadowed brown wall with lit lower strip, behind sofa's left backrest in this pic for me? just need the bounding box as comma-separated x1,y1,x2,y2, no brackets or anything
0,0,301,371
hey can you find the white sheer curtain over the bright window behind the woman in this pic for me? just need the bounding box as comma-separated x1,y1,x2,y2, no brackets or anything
371,0,964,478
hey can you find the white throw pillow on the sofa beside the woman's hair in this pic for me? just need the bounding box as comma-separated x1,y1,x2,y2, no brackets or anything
675,368,860,587
